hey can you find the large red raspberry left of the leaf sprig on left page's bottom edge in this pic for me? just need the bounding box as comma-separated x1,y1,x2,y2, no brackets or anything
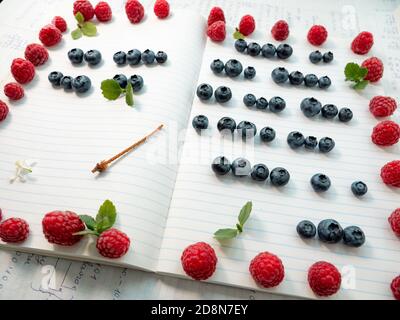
42,211,85,246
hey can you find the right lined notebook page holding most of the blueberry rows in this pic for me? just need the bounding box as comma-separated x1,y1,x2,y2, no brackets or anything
159,32,400,299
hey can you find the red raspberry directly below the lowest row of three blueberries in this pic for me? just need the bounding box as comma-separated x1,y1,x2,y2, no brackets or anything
308,261,342,297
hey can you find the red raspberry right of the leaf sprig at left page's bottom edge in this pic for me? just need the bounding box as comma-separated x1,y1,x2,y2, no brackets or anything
96,229,131,259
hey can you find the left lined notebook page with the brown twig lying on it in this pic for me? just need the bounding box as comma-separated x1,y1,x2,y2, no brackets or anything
0,3,205,269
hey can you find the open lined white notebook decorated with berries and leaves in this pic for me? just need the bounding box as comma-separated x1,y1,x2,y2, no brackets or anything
0,6,400,298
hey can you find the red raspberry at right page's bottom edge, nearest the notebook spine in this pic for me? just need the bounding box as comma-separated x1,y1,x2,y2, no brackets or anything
181,242,218,280
